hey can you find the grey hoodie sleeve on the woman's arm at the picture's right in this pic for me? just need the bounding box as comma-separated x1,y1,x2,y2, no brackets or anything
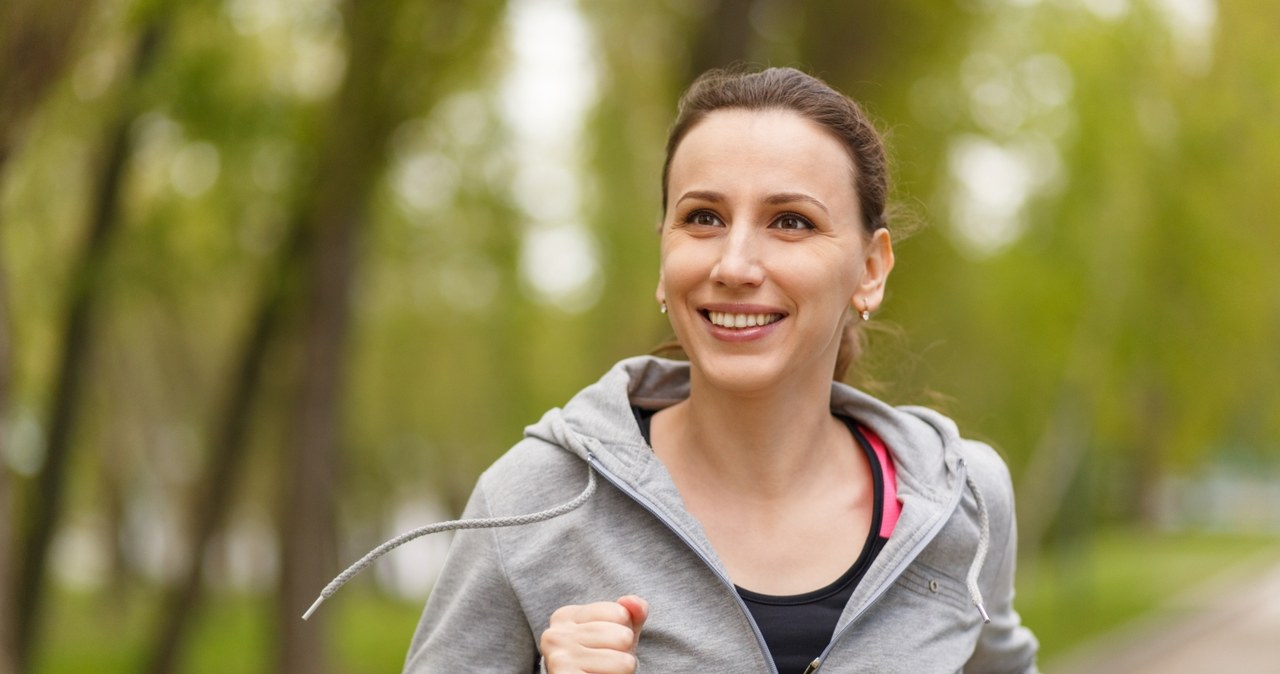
964,445,1039,674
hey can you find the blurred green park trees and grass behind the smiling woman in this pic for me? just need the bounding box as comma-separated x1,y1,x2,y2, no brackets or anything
0,0,1280,674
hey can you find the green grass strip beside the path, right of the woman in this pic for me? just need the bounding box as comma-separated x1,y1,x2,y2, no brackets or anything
1015,529,1280,665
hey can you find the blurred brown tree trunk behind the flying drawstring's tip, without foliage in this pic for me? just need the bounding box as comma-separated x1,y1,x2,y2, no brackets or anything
275,3,396,674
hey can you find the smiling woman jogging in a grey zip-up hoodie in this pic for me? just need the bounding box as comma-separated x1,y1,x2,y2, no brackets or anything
320,69,1037,674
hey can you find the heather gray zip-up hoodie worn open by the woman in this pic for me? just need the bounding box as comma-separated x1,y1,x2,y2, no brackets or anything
404,357,1037,674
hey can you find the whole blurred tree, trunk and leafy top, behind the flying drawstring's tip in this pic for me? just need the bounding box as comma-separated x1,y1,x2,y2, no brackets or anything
276,1,503,674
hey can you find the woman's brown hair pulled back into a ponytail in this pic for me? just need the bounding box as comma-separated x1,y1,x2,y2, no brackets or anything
659,68,888,380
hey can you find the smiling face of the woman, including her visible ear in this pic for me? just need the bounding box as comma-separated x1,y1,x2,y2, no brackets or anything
657,110,893,394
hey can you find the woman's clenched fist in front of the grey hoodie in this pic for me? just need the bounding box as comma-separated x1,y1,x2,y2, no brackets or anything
539,595,649,674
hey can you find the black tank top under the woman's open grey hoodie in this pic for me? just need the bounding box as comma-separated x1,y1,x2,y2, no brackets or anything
632,407,887,674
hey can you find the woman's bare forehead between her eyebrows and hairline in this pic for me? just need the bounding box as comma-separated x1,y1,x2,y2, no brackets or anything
669,109,854,198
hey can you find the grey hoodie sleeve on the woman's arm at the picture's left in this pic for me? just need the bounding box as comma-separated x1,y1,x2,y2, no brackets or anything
404,481,539,674
